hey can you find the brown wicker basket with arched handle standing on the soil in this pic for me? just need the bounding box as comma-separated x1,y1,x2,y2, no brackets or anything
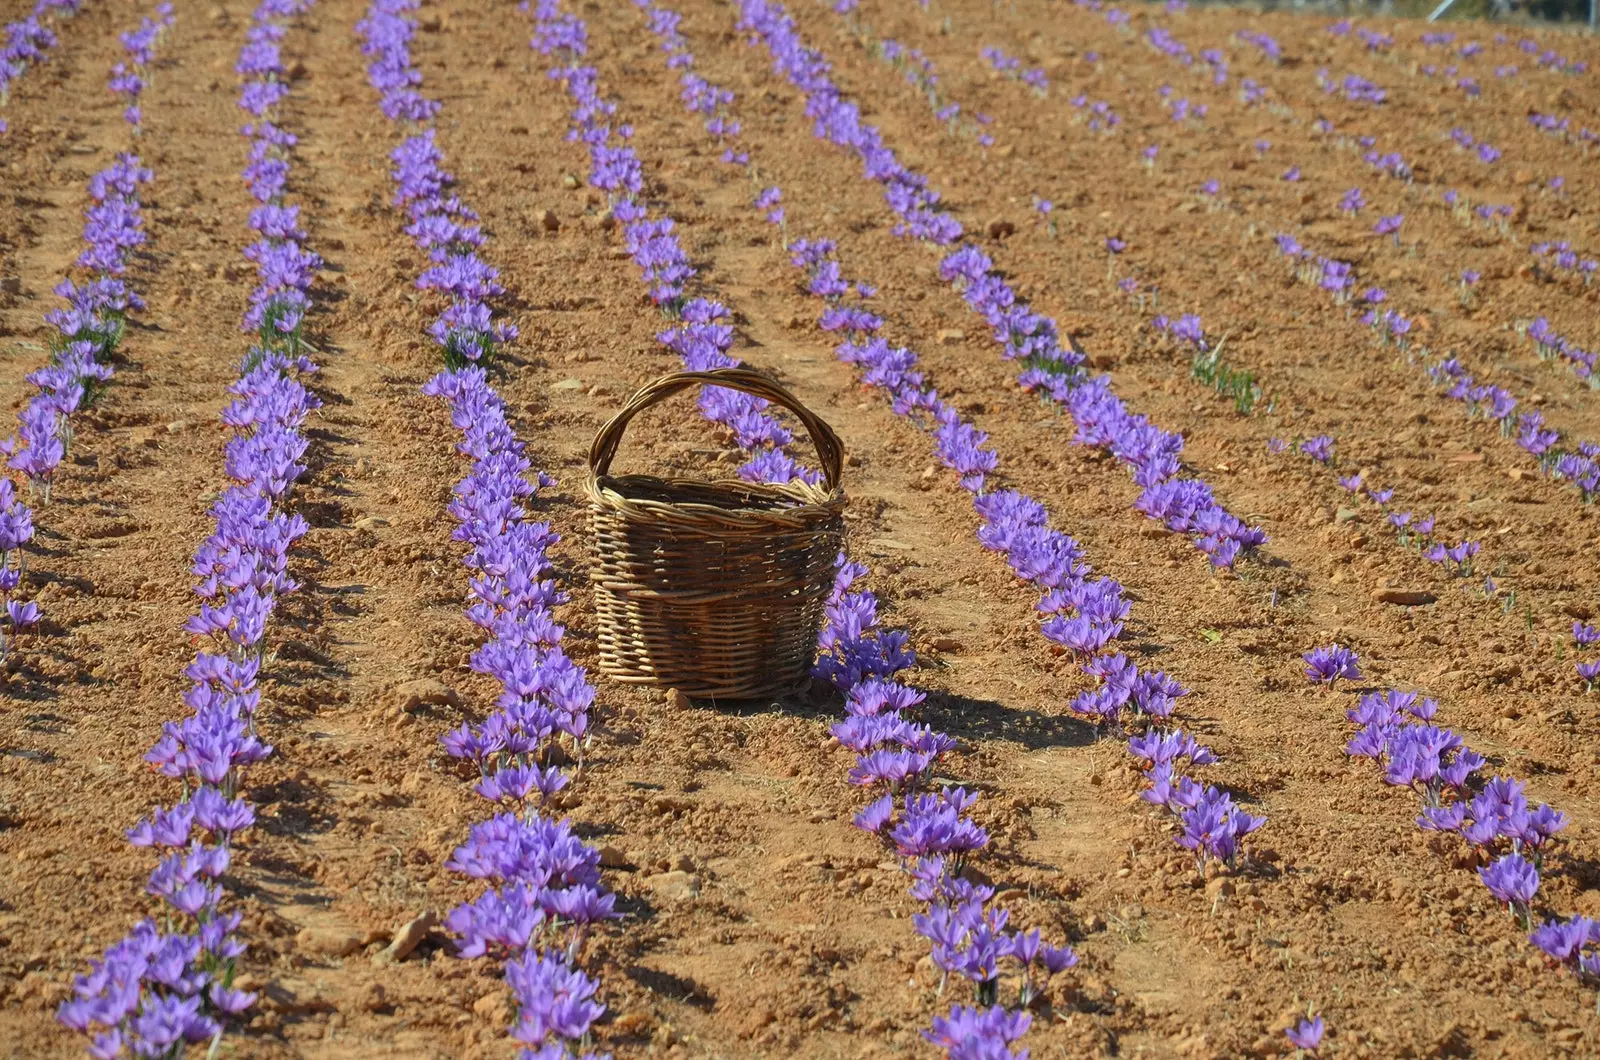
587,368,845,700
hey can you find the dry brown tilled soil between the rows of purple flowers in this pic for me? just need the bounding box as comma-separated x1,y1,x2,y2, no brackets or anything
0,0,1600,1057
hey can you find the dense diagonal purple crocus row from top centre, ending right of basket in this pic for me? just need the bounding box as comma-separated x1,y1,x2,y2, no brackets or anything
739,0,1266,567
